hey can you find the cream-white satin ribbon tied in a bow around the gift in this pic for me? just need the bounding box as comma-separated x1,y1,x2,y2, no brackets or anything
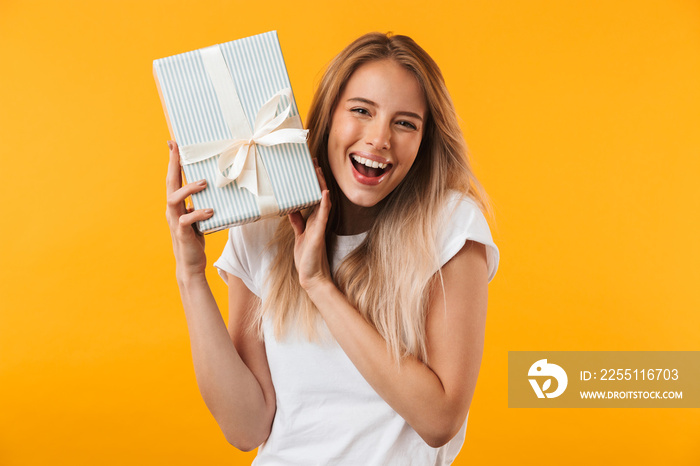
180,45,308,216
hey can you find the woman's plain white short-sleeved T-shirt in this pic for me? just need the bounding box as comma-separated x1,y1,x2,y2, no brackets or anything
214,191,499,466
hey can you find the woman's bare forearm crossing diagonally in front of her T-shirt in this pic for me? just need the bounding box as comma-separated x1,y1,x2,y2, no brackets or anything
308,282,471,446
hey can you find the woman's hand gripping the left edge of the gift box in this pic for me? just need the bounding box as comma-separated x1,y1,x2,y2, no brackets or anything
165,141,214,275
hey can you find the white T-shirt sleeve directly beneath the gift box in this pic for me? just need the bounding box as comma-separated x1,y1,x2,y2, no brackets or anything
214,218,279,297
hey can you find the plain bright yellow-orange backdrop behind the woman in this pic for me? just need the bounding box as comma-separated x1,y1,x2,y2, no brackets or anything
0,0,700,466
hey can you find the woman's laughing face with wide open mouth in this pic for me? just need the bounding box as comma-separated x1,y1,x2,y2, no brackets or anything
328,60,427,222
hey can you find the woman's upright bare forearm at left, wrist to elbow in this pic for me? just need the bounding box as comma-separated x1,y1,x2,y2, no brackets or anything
178,271,274,450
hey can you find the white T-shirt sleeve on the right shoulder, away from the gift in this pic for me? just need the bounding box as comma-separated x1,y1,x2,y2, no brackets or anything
439,193,499,282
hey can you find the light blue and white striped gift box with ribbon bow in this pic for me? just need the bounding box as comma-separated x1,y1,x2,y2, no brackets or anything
153,31,321,233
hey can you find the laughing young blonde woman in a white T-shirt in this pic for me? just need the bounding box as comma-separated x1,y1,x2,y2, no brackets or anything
167,33,498,465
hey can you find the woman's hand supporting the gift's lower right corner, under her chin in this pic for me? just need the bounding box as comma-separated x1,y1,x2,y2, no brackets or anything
289,167,331,292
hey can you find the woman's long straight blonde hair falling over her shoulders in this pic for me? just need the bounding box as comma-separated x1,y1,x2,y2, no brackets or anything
256,33,488,362
